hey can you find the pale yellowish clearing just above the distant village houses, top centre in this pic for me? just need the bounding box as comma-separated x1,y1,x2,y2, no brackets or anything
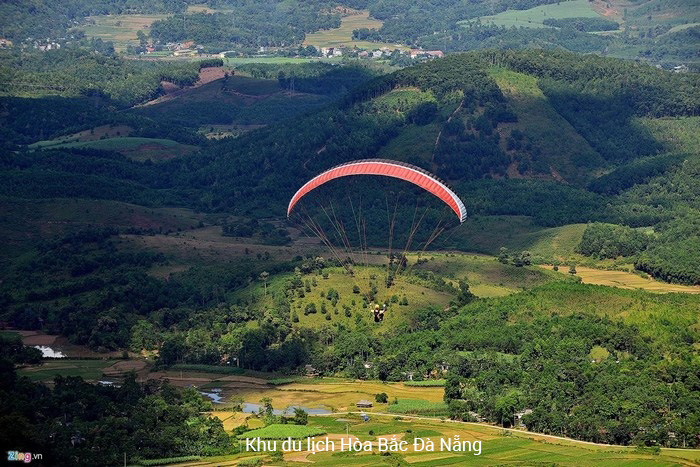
304,10,408,50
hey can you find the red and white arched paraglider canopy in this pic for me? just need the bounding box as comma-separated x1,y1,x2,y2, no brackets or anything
287,159,467,223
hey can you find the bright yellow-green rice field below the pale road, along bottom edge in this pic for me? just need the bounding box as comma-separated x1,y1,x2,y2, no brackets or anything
189,414,700,467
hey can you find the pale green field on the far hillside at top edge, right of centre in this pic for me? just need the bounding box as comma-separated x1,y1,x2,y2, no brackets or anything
469,0,600,28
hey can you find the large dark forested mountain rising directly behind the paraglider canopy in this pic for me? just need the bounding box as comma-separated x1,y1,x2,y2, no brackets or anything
3,51,700,283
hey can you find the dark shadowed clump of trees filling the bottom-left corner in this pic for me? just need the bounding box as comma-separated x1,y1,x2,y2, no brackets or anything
0,368,238,465
